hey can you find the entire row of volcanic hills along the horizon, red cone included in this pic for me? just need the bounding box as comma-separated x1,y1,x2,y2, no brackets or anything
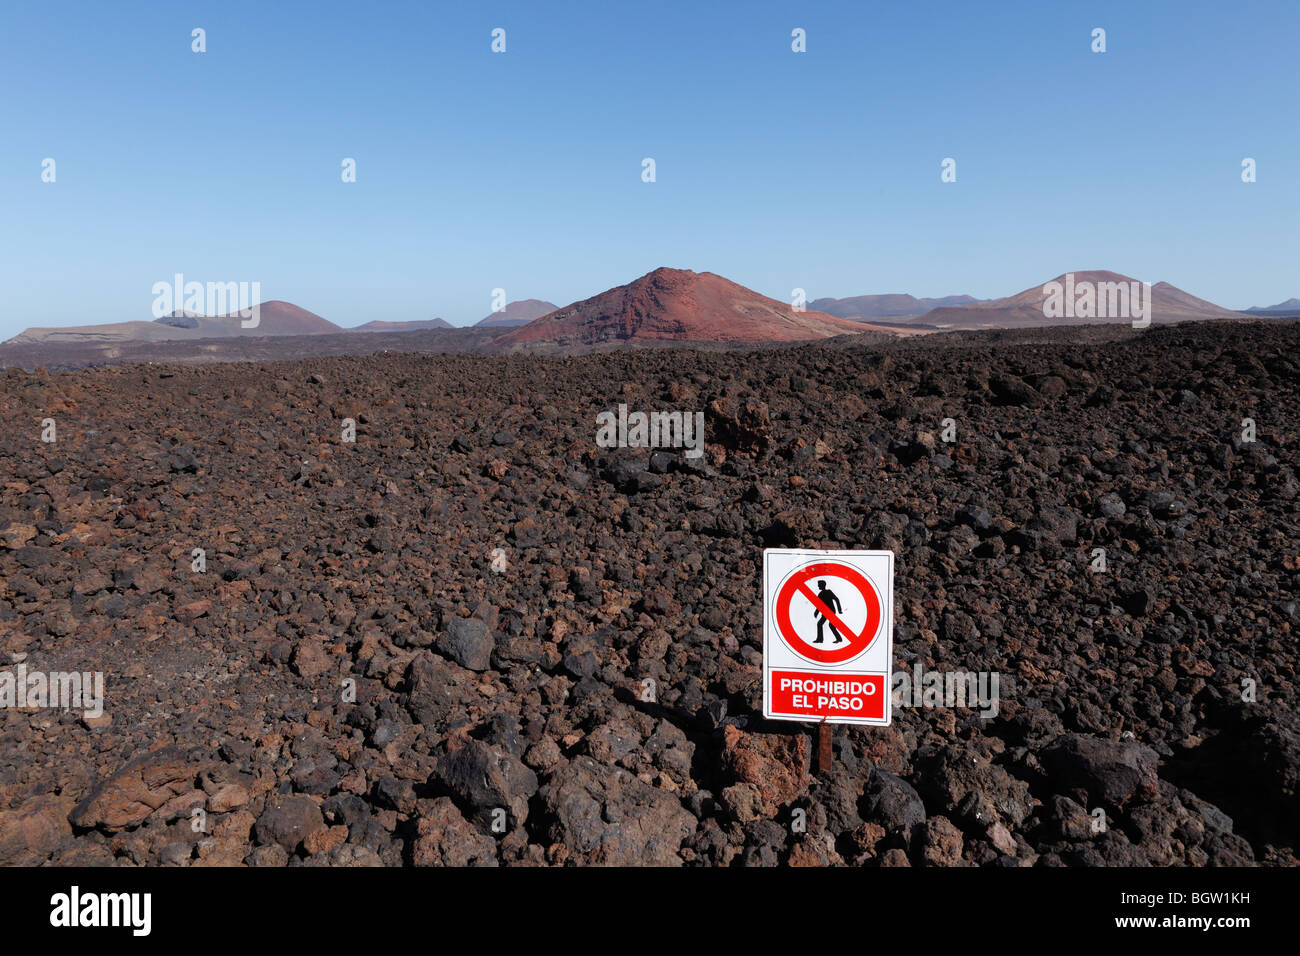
4,268,1268,350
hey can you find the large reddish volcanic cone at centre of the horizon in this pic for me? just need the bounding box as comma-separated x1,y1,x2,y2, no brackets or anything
497,268,894,349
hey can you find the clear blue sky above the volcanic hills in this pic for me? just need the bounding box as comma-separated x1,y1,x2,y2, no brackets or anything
0,0,1300,337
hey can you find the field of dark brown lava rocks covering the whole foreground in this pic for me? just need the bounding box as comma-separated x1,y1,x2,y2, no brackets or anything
0,323,1300,866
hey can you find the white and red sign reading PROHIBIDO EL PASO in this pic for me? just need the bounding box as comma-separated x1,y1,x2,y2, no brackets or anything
763,548,893,724
